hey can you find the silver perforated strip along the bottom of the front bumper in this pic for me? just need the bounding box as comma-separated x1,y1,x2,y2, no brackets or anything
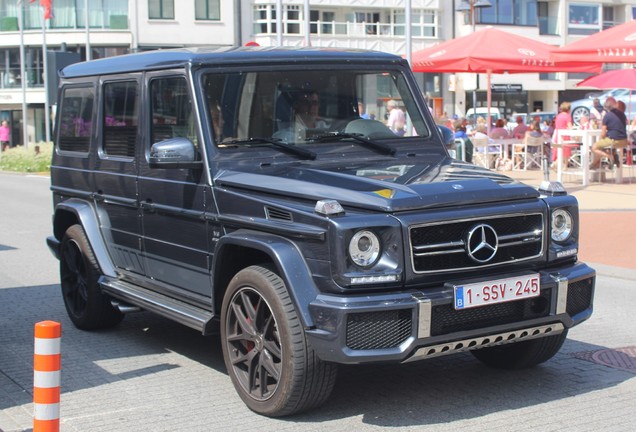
402,323,565,363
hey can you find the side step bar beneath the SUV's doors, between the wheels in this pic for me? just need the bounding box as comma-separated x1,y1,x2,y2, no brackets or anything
99,278,215,335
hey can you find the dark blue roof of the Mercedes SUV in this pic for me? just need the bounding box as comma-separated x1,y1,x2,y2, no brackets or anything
60,47,406,78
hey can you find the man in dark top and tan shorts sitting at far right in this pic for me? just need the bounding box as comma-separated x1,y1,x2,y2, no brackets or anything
590,96,627,169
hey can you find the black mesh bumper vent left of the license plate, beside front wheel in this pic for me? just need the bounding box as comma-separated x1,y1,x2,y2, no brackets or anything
347,309,412,350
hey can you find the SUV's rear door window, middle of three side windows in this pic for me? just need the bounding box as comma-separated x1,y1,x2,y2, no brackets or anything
102,81,139,157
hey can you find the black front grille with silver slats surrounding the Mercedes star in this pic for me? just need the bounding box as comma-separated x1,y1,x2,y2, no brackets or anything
410,213,544,273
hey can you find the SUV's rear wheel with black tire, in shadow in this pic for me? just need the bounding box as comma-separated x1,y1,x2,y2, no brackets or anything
60,225,124,330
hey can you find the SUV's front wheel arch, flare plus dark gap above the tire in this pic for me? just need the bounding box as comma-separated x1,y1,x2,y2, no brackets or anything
212,230,319,327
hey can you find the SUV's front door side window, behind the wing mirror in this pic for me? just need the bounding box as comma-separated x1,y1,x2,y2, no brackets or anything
150,77,197,146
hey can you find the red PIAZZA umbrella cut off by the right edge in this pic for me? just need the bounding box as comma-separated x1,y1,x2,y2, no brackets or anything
552,20,636,63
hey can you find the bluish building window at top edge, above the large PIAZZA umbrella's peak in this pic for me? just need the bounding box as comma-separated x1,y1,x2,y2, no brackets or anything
482,0,537,26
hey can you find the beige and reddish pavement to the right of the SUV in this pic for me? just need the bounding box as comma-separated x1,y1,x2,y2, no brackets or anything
506,167,636,270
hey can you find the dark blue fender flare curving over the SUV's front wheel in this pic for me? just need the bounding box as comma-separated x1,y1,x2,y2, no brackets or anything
213,230,319,328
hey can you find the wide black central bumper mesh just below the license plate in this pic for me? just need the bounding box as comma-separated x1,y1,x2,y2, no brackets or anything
431,289,552,336
